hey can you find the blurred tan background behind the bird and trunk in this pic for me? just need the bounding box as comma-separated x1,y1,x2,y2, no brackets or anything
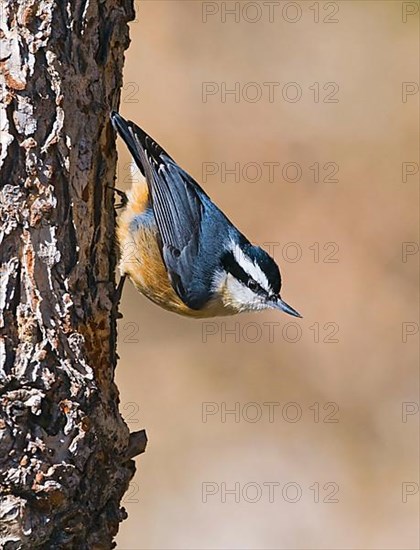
113,0,419,550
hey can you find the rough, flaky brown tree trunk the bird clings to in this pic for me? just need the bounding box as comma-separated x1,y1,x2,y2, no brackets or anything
0,0,145,550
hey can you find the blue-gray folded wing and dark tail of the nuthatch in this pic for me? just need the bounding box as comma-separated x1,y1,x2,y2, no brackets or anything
112,113,211,309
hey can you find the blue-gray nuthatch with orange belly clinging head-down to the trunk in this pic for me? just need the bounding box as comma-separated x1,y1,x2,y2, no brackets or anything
111,111,301,318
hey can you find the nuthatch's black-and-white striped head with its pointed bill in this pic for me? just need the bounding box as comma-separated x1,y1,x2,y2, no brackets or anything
215,241,301,317
